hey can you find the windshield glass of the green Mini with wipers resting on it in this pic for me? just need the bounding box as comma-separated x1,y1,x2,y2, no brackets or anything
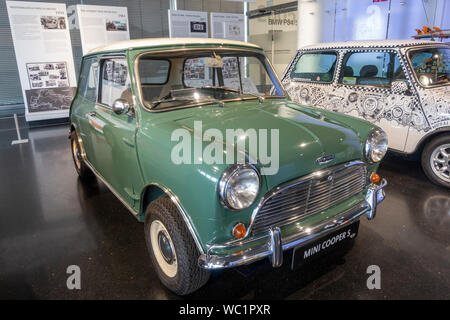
138,49,285,110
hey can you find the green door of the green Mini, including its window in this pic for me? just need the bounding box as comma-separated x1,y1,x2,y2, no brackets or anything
88,56,142,209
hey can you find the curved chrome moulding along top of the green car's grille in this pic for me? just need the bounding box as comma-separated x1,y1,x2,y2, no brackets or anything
234,160,365,243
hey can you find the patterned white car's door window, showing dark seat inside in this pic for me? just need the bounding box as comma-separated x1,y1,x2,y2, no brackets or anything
339,52,406,88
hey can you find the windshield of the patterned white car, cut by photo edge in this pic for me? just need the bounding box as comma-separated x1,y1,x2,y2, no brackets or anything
409,48,450,87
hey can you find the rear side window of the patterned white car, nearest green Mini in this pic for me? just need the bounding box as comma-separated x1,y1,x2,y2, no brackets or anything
290,52,337,82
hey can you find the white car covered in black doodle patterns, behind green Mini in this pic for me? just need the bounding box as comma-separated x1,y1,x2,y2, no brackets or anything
283,40,450,188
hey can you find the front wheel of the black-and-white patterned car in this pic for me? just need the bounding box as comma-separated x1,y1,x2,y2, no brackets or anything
422,134,450,188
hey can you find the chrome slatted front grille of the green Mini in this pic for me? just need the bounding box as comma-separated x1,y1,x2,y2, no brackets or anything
251,161,367,234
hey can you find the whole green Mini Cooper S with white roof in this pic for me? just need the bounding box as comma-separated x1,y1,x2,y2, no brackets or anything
70,39,388,295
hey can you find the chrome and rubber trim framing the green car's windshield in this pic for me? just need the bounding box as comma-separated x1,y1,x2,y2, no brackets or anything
134,47,288,112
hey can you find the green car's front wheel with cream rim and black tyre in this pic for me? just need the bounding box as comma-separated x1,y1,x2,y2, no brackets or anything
144,196,209,295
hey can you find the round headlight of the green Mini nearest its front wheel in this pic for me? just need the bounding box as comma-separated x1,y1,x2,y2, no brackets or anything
219,164,260,210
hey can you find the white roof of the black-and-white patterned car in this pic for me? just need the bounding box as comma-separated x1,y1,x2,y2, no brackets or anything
299,40,444,50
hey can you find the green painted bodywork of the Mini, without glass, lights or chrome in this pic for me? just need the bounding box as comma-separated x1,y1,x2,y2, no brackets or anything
70,40,378,252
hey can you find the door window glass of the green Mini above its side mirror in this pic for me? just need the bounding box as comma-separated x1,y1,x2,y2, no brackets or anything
99,58,133,106
